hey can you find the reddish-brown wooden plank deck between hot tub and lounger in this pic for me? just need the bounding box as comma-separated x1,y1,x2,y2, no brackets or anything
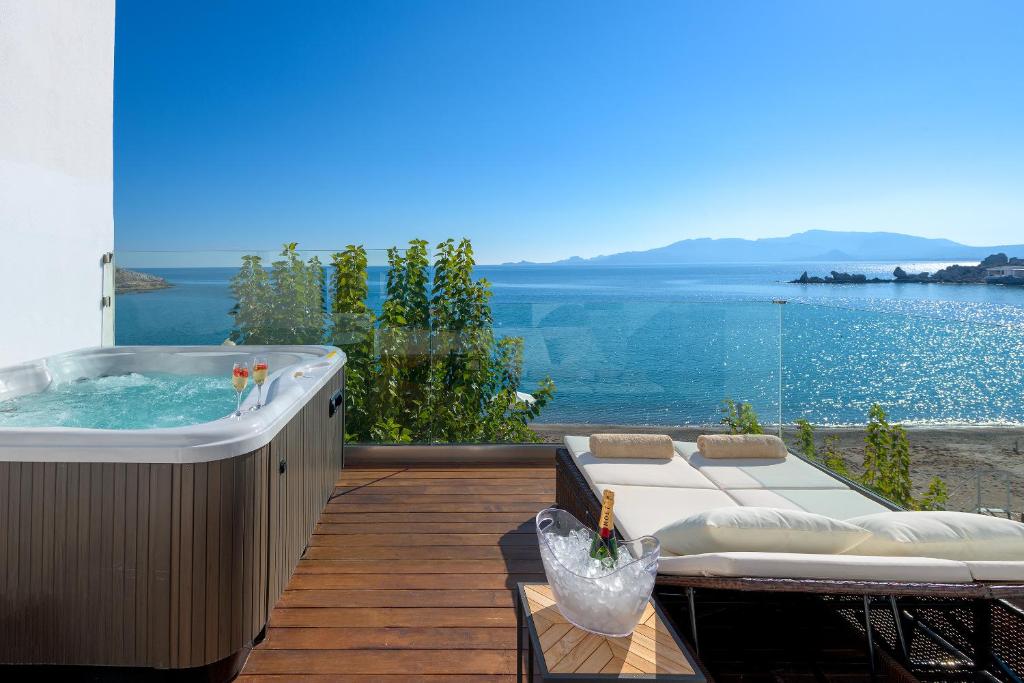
238,465,555,683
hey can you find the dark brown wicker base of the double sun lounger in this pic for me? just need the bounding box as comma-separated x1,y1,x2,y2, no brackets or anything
555,449,1024,681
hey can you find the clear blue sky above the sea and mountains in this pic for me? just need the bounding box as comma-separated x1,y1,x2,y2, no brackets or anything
114,0,1024,263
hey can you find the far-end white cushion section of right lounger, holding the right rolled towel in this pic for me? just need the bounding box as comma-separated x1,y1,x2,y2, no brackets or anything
676,441,848,488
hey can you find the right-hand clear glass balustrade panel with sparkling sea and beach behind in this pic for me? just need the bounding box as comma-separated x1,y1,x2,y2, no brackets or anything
782,303,1024,517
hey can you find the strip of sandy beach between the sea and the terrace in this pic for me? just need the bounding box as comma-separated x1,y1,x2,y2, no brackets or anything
532,424,1024,511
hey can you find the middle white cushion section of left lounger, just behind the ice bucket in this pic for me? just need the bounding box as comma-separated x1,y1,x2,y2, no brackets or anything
596,484,736,539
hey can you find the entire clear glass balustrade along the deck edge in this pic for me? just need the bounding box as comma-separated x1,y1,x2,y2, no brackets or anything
116,250,1024,515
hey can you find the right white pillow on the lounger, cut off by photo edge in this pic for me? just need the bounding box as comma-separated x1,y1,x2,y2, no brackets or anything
847,512,1024,560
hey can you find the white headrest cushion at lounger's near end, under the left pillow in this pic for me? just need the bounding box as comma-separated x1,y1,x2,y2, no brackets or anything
657,553,973,584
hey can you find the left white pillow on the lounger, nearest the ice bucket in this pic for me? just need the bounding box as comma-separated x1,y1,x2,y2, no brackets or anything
654,507,870,555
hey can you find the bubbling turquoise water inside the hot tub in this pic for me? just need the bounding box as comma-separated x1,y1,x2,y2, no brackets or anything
0,373,253,429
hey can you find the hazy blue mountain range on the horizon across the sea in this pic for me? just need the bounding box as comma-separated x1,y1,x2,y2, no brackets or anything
510,230,1024,265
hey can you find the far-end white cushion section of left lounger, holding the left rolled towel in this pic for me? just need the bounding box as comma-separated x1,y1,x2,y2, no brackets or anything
565,436,718,488
